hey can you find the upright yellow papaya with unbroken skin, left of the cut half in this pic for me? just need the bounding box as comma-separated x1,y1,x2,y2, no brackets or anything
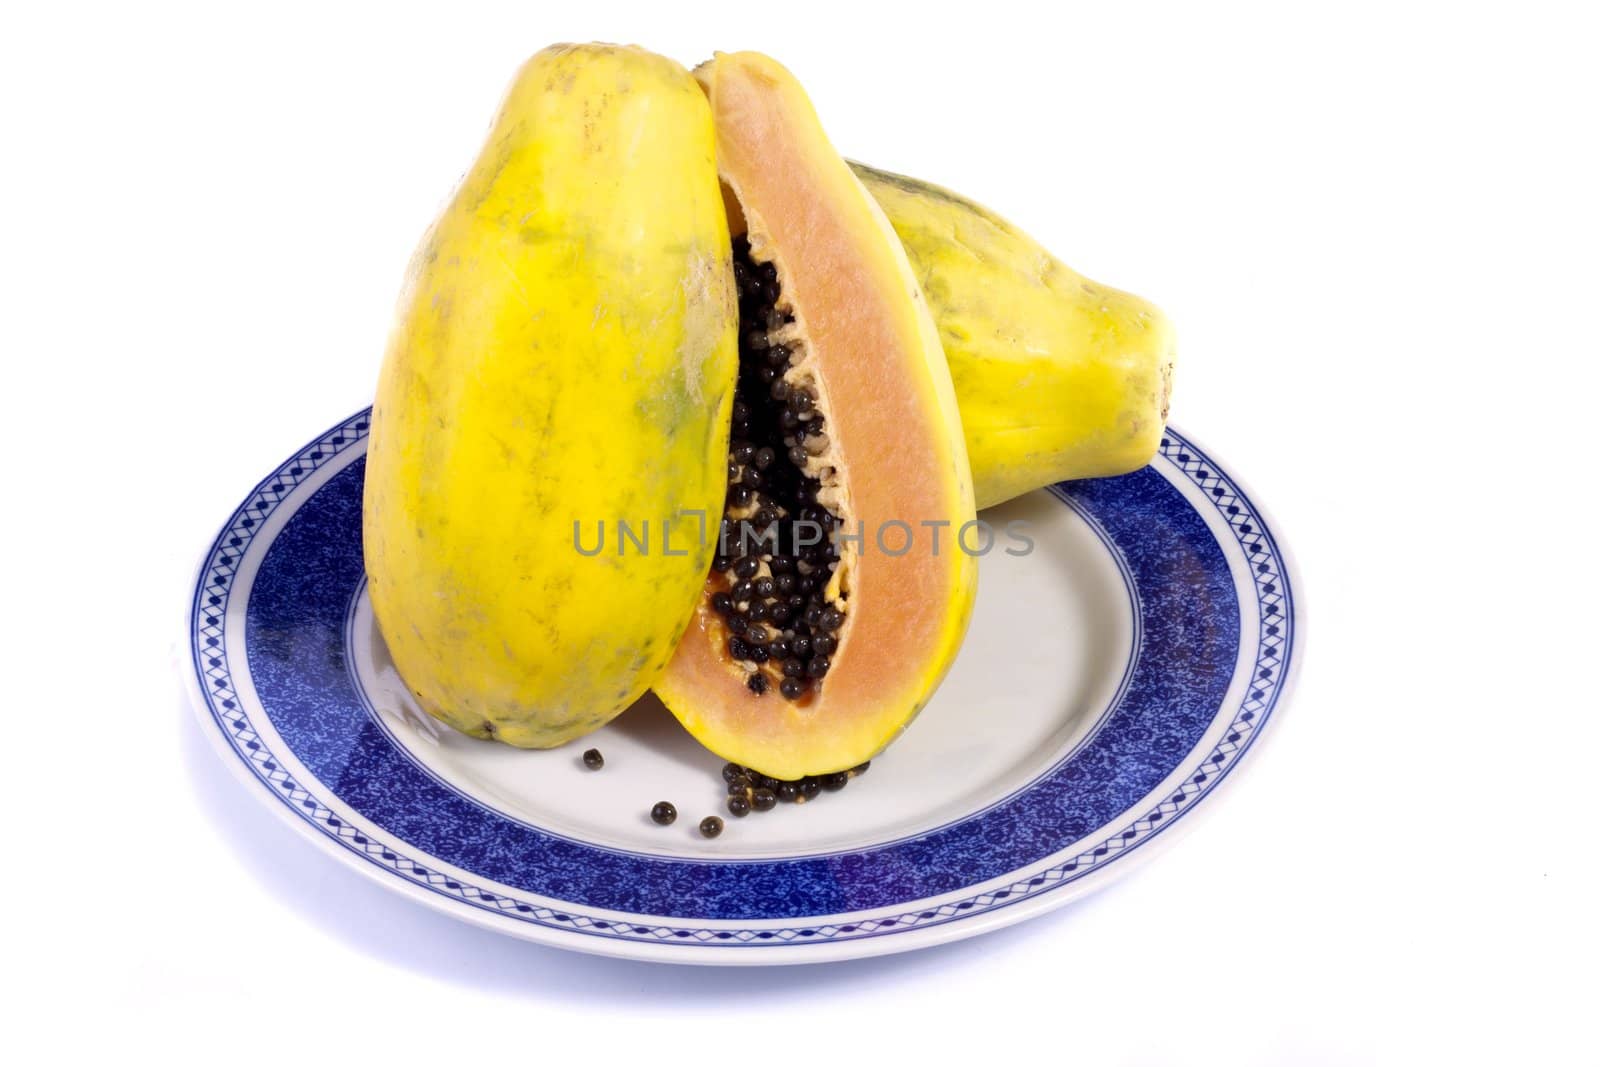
363,45,738,749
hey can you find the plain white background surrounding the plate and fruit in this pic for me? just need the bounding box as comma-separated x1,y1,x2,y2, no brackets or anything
0,0,1600,1064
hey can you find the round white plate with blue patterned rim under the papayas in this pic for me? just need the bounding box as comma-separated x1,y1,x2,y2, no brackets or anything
189,411,1299,963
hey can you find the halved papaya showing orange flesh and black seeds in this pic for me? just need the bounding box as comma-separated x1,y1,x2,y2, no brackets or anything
656,53,976,779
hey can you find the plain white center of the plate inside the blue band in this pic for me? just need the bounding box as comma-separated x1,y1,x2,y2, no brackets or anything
350,491,1134,859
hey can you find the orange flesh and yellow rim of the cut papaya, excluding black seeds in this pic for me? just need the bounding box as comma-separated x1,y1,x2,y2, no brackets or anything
656,53,978,779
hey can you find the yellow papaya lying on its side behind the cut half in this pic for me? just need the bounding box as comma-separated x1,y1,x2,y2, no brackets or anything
851,163,1176,507
